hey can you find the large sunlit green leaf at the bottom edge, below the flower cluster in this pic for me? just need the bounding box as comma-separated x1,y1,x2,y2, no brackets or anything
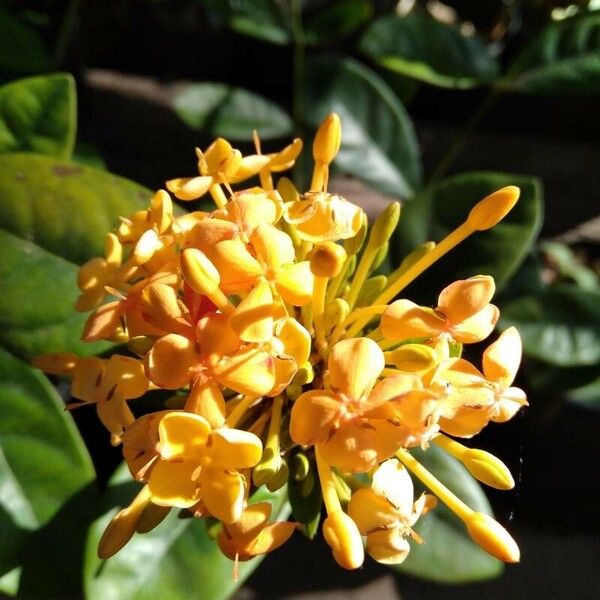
84,469,289,600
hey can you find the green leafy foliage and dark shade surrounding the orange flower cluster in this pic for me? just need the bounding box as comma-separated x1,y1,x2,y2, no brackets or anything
0,0,600,600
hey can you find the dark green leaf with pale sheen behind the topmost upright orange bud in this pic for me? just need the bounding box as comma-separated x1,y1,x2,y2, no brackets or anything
302,56,421,199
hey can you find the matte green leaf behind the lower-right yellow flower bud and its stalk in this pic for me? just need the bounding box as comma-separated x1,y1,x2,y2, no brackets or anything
395,446,502,583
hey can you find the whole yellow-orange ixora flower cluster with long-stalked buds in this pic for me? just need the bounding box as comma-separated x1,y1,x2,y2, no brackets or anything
35,114,527,569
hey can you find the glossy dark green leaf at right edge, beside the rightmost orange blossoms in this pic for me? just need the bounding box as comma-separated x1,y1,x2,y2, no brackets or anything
499,285,600,367
